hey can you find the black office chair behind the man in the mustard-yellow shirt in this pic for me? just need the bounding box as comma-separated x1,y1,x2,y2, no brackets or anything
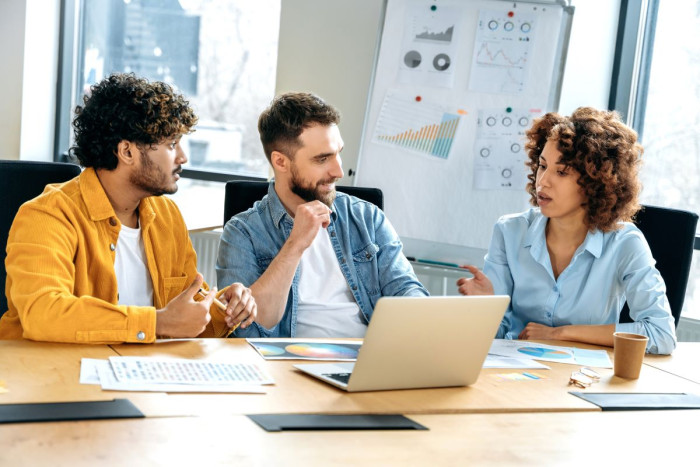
0,160,80,316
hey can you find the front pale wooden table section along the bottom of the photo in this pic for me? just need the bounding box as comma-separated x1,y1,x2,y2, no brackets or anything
0,411,700,467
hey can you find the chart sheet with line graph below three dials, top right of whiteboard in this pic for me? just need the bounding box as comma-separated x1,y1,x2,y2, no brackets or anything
469,10,535,95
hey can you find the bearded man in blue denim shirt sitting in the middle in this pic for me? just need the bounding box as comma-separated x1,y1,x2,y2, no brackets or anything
217,93,428,337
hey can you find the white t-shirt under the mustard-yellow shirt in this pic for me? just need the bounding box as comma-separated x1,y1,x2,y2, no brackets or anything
114,225,153,306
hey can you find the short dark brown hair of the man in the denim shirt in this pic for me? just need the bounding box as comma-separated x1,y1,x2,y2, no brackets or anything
258,92,340,161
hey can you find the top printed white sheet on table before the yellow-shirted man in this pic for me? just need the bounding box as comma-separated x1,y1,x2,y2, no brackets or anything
109,357,274,385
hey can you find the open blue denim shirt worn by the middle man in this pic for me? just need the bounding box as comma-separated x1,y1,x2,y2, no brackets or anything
216,181,428,337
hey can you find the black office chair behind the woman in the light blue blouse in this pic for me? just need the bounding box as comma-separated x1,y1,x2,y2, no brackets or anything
620,206,698,327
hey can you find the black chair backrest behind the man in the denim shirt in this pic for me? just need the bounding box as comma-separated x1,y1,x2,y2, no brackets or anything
224,180,384,224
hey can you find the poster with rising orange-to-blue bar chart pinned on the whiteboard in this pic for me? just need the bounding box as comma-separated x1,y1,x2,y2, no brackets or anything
372,92,463,160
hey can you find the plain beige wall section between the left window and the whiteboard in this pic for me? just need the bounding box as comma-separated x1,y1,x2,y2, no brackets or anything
276,0,384,185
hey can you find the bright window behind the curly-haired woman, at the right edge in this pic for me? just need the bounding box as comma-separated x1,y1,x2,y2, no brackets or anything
611,0,700,319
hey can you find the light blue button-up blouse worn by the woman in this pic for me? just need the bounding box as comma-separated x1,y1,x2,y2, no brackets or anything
484,208,676,354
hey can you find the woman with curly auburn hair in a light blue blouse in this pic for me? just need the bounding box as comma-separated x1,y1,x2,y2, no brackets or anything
457,107,676,354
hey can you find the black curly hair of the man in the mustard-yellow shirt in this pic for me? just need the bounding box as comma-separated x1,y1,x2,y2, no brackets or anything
70,73,197,170
